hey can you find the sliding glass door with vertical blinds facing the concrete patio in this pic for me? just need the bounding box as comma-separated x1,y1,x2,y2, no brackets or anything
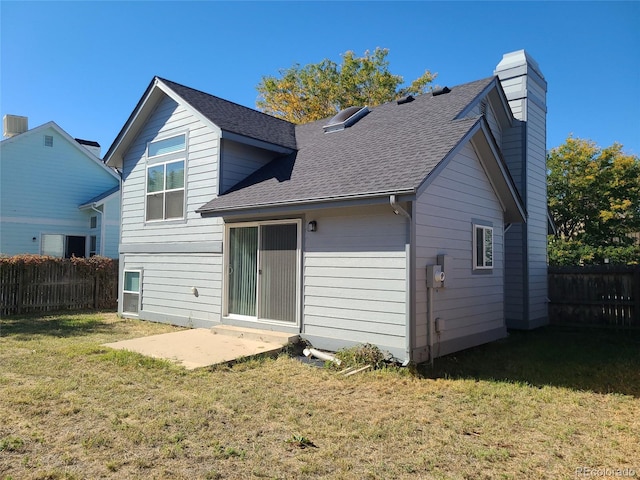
227,222,299,323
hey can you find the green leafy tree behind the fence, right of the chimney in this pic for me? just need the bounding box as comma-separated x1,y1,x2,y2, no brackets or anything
547,136,640,265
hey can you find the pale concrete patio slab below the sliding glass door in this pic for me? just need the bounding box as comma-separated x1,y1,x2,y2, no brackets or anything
104,326,298,370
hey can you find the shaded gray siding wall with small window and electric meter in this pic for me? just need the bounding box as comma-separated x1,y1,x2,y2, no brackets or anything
415,144,506,354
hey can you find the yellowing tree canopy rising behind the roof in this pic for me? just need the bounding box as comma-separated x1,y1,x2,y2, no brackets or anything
257,47,436,123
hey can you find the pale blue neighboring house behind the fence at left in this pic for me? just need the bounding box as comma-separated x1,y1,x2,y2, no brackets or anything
0,115,120,258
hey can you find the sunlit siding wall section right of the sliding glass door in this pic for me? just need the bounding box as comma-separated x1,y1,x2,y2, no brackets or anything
303,206,407,351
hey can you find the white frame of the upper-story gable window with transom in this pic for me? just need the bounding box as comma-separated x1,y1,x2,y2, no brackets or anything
144,132,189,223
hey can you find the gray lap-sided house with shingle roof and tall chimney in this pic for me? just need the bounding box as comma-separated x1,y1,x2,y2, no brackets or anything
106,51,547,363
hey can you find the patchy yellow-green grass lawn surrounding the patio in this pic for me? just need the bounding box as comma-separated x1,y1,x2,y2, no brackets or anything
0,313,640,480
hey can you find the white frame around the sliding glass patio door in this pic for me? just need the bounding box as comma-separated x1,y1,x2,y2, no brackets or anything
222,218,302,327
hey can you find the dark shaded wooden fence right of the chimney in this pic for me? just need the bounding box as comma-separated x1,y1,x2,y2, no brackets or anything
548,265,640,328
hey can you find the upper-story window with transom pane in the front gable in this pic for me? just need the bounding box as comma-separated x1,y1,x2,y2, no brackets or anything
146,134,187,222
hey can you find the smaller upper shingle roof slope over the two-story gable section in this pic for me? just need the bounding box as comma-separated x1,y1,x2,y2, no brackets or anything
158,77,296,148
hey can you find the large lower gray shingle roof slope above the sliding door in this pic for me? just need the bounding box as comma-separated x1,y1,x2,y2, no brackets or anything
195,77,494,213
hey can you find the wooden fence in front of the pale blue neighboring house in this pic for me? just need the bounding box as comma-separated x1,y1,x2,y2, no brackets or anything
0,255,118,316
